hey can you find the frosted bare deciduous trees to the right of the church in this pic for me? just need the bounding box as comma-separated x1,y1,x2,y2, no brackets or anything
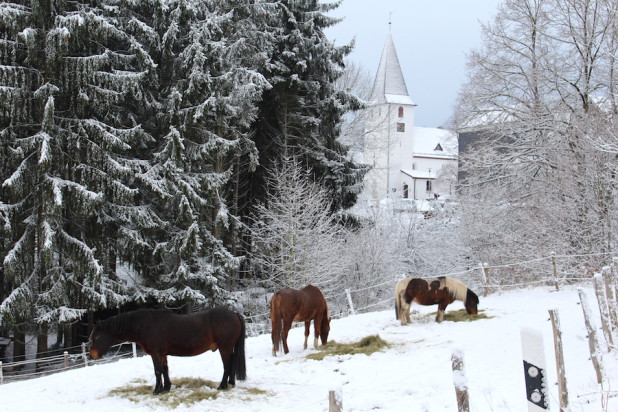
455,0,618,276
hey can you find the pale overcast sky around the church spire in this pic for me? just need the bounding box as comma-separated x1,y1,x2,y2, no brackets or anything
323,0,501,127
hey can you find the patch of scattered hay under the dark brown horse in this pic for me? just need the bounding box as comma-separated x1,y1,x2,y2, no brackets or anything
109,378,269,409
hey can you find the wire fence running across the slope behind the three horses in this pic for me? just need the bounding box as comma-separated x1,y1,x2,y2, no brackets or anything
0,254,618,384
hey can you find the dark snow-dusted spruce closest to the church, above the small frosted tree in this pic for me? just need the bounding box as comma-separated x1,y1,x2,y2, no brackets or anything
246,0,364,220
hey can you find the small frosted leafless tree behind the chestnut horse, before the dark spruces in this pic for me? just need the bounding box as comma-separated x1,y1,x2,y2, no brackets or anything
252,155,350,294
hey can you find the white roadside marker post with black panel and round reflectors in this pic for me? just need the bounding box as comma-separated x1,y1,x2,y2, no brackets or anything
521,328,549,412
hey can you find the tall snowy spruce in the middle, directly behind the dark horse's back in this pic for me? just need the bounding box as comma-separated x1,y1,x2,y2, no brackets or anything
130,0,267,304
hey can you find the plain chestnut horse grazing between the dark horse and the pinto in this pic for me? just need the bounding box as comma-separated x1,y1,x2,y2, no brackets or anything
270,285,330,356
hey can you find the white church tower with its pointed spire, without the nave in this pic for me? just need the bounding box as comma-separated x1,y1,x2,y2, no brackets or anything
363,33,415,200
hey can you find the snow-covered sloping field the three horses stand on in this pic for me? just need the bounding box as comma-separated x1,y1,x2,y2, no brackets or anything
0,287,618,412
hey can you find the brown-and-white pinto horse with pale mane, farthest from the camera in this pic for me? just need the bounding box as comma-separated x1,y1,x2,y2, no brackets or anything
403,276,479,322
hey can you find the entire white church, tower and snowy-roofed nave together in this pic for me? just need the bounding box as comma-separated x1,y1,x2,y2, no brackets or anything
360,33,458,202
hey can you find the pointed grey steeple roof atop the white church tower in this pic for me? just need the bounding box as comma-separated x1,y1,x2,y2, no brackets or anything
370,33,414,105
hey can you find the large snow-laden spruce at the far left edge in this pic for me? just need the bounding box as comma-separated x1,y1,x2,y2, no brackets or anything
0,1,152,352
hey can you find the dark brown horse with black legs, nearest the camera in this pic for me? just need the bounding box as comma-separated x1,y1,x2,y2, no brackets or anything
90,308,247,394
